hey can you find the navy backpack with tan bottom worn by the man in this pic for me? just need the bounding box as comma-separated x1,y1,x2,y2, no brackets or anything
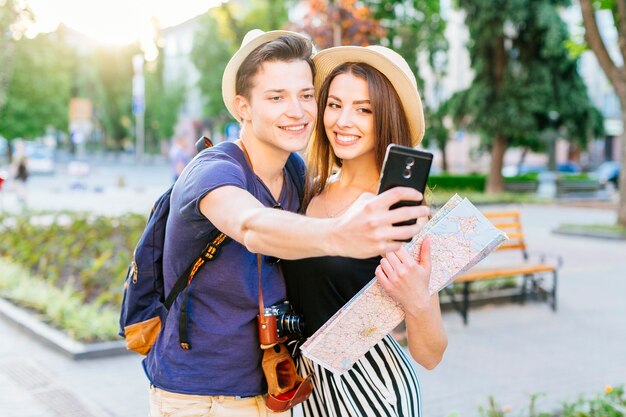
119,137,304,355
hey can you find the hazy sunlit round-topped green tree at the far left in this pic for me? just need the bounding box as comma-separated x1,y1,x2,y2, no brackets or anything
0,33,76,138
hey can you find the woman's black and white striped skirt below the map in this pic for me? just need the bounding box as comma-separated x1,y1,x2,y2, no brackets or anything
298,335,421,417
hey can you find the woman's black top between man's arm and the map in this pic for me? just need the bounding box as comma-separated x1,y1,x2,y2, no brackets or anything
281,256,381,337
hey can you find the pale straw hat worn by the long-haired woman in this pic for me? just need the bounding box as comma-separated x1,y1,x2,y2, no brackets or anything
313,46,424,146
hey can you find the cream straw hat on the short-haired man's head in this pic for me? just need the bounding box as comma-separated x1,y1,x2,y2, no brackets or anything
222,29,310,120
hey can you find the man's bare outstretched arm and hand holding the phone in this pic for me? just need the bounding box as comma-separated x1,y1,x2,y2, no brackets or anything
200,186,429,259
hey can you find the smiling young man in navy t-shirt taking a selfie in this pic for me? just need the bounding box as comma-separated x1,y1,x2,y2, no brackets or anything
144,30,428,417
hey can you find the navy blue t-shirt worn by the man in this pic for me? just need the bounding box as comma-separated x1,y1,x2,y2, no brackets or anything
144,142,304,397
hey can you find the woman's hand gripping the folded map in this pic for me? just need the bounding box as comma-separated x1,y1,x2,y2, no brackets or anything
376,237,431,314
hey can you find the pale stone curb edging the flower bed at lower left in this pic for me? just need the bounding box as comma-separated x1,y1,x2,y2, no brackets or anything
0,298,133,360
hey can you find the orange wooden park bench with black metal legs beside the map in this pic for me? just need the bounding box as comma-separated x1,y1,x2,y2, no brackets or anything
445,211,562,324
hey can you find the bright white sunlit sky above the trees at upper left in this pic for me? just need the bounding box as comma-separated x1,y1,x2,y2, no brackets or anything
26,0,220,45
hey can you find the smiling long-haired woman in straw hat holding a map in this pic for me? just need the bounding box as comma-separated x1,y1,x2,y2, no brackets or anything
283,46,447,417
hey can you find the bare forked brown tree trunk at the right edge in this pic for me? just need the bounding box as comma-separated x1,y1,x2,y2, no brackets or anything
580,0,626,227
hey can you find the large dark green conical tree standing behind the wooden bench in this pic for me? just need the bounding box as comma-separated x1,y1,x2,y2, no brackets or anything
451,0,601,192
